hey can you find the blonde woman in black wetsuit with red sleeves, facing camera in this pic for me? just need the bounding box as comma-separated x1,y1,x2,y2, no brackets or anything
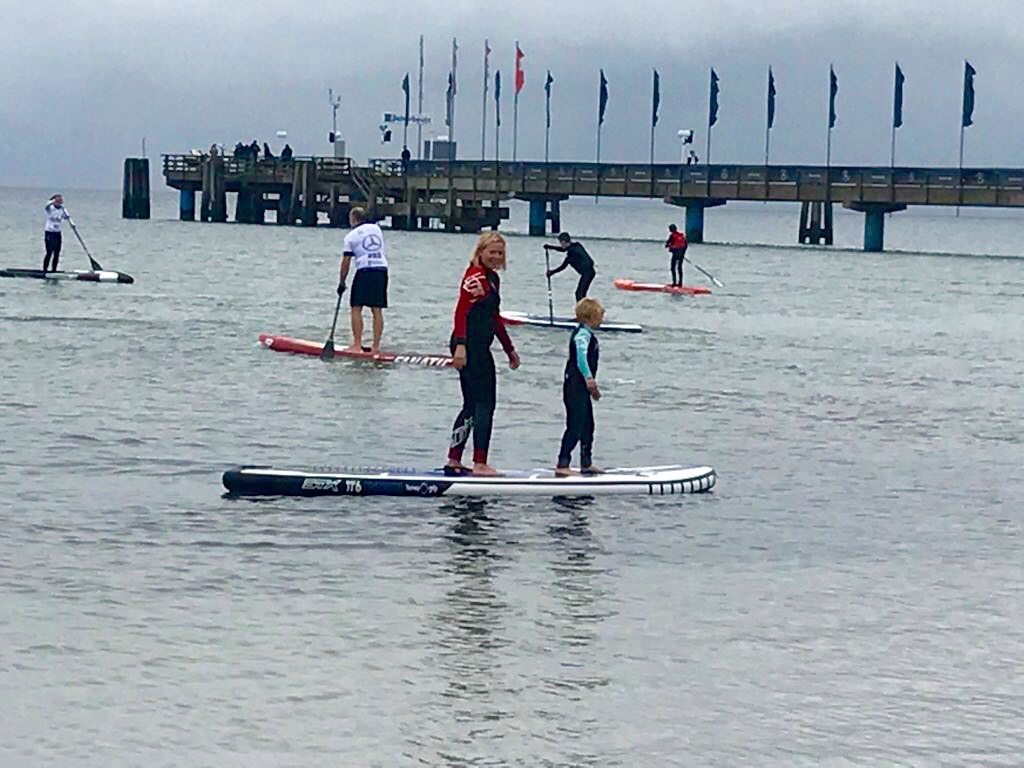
444,232,519,475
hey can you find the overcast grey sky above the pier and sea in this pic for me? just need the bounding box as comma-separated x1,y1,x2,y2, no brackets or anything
0,0,1024,188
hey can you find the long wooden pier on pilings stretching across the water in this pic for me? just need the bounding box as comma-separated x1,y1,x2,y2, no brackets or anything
157,154,1024,251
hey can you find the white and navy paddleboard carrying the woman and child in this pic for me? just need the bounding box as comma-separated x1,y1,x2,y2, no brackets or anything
223,465,717,497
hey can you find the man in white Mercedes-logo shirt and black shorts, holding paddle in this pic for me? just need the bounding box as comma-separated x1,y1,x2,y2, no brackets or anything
338,208,387,354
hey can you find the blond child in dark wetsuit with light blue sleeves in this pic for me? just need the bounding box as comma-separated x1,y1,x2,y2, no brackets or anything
555,299,604,477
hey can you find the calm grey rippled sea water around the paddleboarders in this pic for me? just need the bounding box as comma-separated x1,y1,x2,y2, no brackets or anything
0,190,1024,766
